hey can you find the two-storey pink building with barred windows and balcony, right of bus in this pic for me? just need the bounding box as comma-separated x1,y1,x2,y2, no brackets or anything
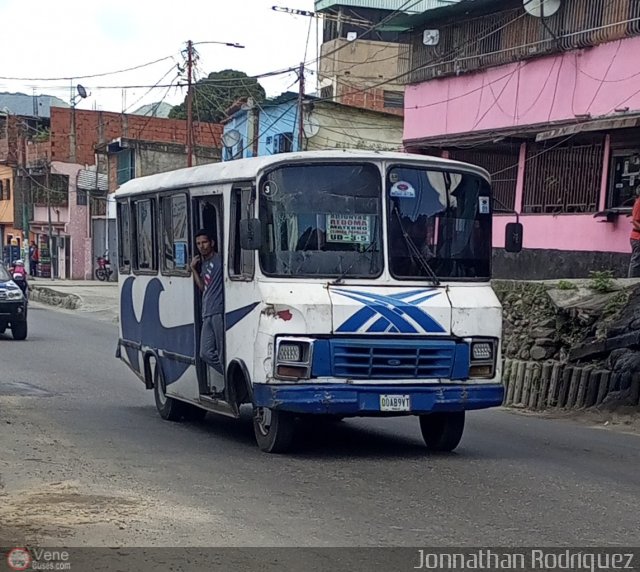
404,0,640,278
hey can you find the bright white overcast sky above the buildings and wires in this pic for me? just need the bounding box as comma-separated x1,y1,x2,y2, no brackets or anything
0,0,321,112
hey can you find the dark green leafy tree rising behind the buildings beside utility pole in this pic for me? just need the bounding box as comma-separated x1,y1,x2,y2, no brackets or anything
169,70,266,123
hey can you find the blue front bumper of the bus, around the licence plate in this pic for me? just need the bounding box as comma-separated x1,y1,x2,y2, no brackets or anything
253,383,504,417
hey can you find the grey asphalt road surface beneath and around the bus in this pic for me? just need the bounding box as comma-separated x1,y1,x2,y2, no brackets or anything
0,306,640,546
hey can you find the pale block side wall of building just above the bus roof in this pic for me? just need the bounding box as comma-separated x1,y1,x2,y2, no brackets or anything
307,102,403,151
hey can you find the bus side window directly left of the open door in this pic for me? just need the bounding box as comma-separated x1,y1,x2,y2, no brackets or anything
161,193,189,274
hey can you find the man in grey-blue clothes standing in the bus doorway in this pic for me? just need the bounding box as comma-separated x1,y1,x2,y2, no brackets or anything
191,230,224,393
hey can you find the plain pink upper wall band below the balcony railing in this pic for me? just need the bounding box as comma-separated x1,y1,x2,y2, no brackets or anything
404,37,640,141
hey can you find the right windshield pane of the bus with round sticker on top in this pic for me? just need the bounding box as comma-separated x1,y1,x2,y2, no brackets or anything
387,166,491,280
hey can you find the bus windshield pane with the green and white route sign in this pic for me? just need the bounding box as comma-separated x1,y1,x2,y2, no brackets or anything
259,163,383,278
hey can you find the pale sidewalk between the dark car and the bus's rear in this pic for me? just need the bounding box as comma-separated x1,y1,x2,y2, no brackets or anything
30,278,118,322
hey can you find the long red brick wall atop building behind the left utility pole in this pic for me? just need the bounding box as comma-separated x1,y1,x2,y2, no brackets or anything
51,107,222,165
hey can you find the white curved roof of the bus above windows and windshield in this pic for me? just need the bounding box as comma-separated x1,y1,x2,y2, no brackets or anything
116,149,490,196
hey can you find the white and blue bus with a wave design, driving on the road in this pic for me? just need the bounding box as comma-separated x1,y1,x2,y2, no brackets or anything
116,151,521,452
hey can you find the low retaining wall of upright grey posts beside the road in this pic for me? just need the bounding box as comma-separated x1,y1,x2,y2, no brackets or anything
503,359,640,411
